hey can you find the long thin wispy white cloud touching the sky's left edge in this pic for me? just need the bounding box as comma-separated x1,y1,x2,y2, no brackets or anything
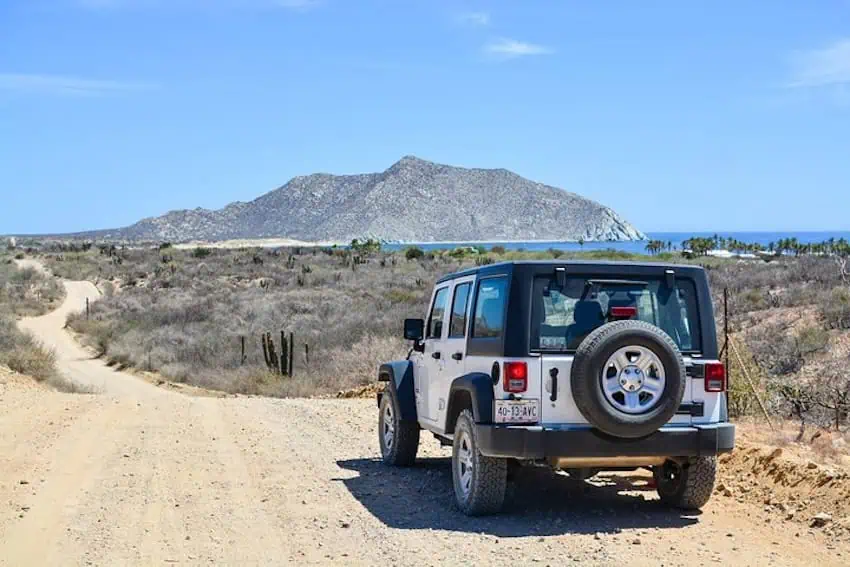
0,73,157,96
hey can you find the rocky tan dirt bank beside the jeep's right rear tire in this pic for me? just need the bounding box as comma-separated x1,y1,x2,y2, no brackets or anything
716,443,850,540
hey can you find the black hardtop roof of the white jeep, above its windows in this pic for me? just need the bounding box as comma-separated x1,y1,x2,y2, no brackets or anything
437,260,705,283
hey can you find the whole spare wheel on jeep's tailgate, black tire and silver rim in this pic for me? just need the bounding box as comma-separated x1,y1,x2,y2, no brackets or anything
570,321,686,438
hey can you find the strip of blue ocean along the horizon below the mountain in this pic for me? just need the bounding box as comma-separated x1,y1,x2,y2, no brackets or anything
384,231,850,253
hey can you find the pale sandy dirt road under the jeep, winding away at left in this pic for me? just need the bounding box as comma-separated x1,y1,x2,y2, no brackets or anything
0,272,850,566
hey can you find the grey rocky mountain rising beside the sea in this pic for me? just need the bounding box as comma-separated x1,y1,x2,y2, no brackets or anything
71,156,645,242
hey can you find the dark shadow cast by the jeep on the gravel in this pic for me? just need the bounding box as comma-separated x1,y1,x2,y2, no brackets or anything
335,458,699,537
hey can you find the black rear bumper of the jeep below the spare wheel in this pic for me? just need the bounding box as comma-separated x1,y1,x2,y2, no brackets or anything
475,423,735,459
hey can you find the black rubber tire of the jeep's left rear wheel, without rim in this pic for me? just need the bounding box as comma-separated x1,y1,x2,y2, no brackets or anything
452,410,508,516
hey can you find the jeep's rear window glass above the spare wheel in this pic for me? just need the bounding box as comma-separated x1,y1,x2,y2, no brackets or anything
531,276,702,352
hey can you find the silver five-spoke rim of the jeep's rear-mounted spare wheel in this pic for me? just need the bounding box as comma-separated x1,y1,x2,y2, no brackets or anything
601,346,667,415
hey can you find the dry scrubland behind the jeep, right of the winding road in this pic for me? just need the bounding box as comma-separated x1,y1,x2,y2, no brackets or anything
14,242,850,452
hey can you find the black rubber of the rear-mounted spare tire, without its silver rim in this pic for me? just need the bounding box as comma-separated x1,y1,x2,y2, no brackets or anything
570,320,687,439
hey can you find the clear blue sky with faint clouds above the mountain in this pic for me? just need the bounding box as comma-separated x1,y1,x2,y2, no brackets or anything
0,0,850,234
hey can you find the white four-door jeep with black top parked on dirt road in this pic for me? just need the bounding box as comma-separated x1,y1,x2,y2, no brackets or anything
378,262,735,515
